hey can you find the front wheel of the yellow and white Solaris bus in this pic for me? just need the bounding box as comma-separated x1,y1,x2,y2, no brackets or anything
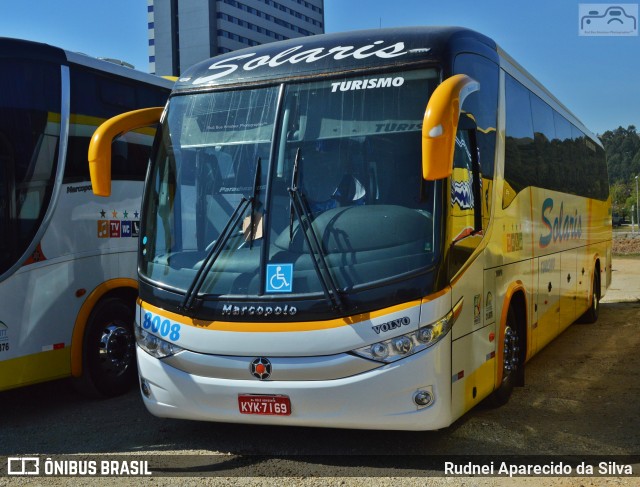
487,307,523,407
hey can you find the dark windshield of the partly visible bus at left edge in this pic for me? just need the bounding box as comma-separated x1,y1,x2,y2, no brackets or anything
0,59,61,275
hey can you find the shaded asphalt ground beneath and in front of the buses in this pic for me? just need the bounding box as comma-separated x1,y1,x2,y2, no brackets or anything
0,259,640,485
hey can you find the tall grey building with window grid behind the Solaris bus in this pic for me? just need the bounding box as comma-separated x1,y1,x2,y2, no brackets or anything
147,0,324,76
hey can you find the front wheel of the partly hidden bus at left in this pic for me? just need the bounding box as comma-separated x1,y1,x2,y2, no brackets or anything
78,296,137,397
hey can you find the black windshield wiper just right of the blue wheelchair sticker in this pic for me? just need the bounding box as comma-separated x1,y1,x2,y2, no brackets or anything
287,148,344,311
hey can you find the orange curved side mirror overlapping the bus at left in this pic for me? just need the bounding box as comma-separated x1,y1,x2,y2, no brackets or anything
88,107,164,196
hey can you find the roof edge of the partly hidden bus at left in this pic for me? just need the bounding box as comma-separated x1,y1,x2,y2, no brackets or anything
0,37,173,89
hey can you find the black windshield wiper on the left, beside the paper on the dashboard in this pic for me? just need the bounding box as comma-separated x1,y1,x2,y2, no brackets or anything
179,157,261,311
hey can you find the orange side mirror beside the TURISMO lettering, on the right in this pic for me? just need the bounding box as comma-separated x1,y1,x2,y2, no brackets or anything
422,74,480,181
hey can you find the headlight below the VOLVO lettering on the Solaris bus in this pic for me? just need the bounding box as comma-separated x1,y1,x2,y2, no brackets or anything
352,299,462,363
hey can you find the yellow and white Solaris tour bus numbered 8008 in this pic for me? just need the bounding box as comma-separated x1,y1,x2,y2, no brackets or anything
89,27,612,430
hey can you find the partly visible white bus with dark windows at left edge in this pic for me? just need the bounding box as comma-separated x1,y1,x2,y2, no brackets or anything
0,38,173,395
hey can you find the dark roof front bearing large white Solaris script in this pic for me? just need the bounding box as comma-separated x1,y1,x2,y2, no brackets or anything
174,27,497,92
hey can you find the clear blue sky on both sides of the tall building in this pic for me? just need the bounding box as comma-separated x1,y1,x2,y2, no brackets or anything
0,0,640,134
